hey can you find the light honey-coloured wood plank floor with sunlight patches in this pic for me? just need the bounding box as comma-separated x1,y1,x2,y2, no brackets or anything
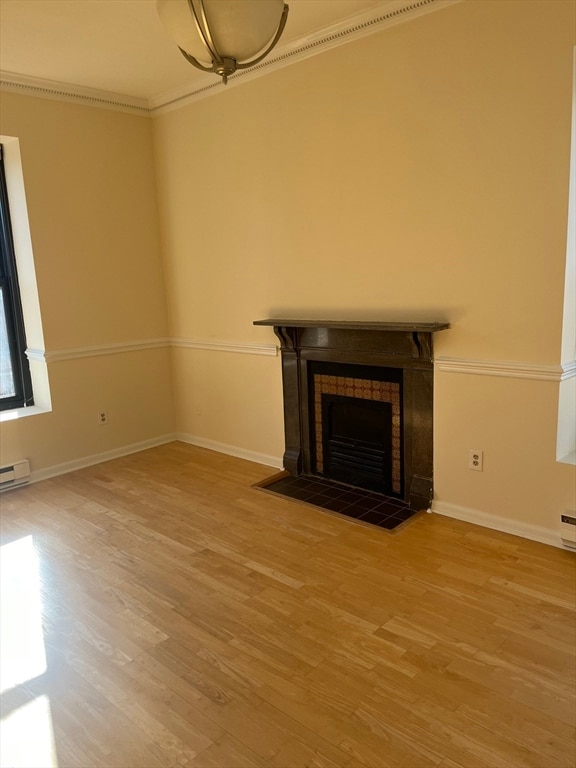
0,443,576,768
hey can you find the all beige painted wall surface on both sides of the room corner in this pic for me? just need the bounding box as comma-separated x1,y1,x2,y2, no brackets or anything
0,0,575,530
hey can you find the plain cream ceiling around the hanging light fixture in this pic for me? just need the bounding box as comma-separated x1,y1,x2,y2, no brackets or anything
0,0,397,101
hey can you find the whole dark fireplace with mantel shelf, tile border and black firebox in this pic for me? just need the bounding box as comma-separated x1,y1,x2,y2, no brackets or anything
255,319,449,510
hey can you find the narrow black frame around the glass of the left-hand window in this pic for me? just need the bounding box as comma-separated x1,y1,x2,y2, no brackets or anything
0,144,34,412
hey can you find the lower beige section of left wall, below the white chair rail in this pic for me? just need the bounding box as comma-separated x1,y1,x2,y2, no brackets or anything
0,348,174,477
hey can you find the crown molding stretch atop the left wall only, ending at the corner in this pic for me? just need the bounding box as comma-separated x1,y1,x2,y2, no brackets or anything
0,70,150,115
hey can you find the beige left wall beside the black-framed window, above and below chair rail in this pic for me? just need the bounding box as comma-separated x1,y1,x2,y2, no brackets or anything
0,94,174,473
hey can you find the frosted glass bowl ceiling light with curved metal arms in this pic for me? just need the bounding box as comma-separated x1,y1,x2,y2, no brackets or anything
156,0,288,84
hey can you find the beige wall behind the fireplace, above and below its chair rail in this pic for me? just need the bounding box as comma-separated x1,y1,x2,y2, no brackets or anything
154,0,575,529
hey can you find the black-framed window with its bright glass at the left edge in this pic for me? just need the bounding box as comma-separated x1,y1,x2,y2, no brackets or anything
0,144,34,411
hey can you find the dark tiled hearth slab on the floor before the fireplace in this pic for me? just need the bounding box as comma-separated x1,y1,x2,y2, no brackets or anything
259,475,416,531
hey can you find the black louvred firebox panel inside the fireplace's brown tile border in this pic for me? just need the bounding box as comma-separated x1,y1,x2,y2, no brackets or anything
320,395,393,495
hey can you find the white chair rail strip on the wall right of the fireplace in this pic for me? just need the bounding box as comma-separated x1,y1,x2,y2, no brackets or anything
434,357,576,382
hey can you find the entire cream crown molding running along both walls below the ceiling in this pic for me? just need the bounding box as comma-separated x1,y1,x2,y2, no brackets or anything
0,0,463,116
